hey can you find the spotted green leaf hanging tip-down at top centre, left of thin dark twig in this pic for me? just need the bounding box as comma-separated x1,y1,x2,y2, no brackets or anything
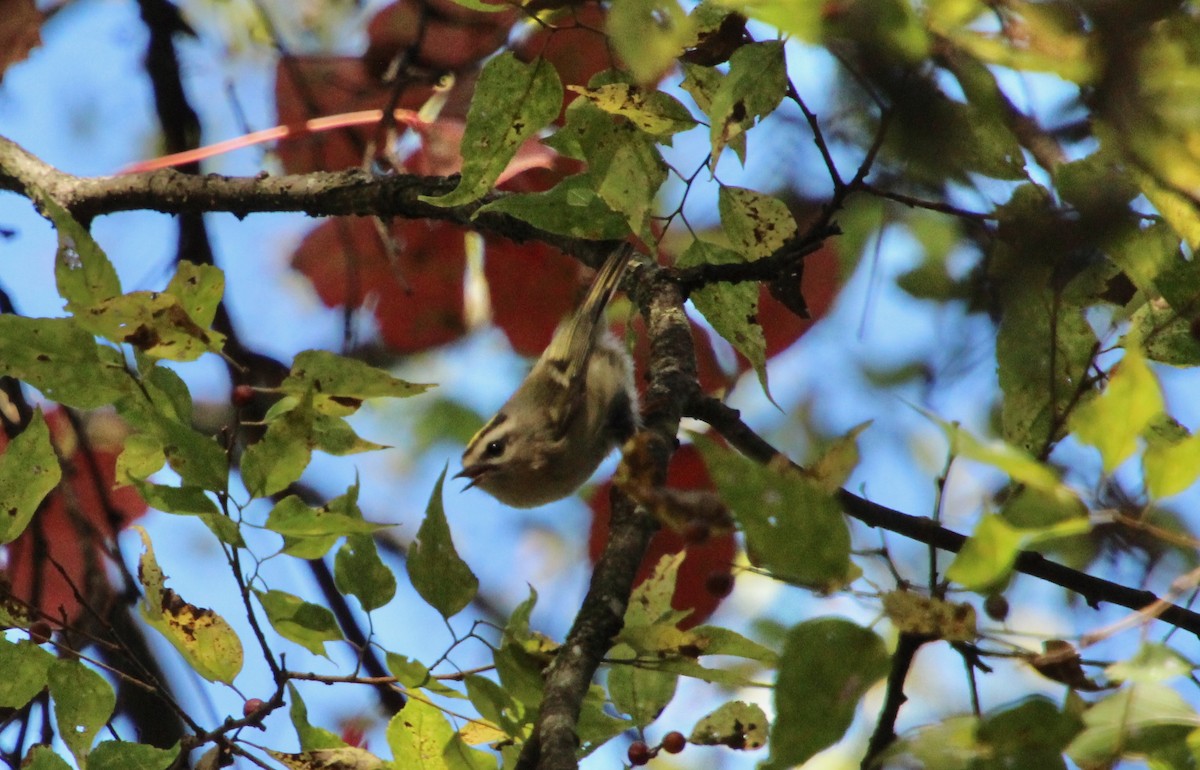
708,41,787,167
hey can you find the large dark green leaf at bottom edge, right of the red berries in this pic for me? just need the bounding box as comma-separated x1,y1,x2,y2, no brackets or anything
762,618,888,770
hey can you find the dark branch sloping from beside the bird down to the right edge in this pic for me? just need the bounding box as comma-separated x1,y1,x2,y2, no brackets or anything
688,398,1200,636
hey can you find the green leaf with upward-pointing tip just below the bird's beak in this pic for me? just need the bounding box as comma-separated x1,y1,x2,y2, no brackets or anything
408,460,479,618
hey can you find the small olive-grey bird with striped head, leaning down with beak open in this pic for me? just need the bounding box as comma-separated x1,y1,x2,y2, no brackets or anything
455,245,637,509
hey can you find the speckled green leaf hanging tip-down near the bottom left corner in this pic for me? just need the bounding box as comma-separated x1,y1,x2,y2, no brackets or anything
48,658,116,769
